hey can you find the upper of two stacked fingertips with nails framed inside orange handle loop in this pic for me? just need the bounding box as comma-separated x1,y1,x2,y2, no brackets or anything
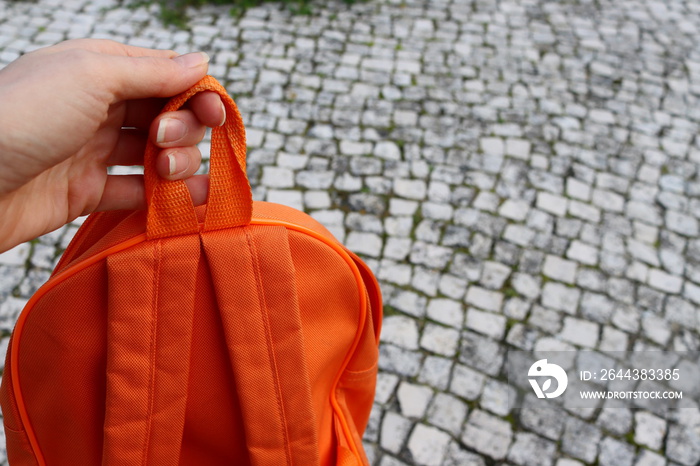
149,110,207,148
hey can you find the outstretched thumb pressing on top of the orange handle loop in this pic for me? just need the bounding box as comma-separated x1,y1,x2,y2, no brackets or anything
101,52,209,100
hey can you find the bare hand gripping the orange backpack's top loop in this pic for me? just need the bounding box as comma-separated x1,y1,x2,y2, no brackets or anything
0,39,226,252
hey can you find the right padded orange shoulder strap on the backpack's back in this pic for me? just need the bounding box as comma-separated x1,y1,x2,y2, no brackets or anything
202,226,319,466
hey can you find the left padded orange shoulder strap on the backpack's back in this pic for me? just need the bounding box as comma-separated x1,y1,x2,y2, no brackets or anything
102,235,200,466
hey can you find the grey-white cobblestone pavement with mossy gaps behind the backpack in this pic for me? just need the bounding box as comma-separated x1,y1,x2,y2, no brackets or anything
0,0,700,466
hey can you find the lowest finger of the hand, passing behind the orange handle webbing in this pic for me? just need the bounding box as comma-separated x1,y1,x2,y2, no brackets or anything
95,175,209,212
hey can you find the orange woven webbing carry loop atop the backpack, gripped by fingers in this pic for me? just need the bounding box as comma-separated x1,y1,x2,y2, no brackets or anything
144,76,253,239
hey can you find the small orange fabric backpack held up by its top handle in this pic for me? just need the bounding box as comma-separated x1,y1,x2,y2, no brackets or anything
0,77,382,466
